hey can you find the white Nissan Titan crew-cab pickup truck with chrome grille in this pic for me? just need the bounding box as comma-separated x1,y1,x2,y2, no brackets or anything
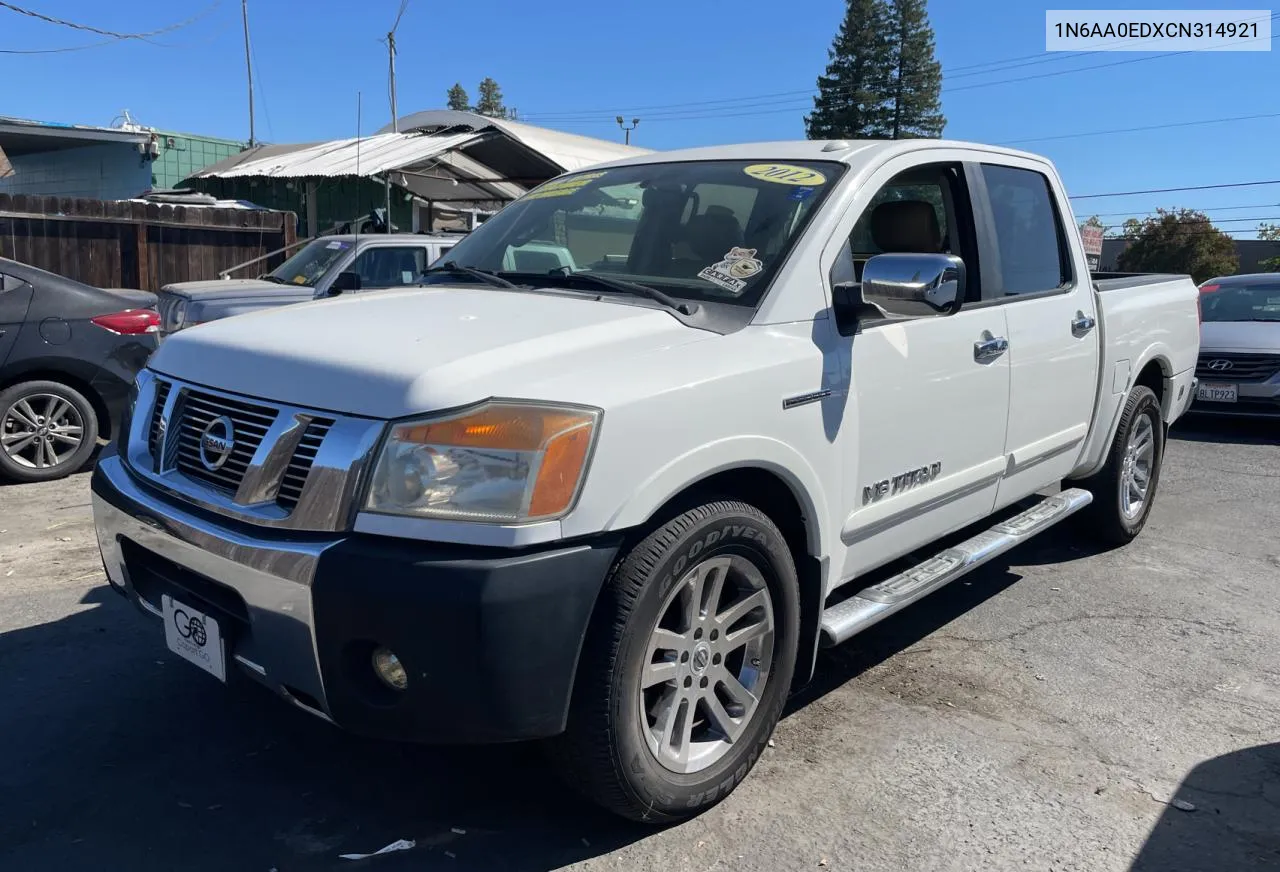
92,141,1198,822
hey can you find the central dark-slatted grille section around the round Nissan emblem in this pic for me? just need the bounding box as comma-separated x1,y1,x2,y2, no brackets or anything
170,388,278,494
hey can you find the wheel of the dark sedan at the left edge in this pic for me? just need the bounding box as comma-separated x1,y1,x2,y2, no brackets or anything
0,382,99,483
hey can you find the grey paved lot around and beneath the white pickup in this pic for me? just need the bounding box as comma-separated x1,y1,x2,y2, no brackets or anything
0,421,1280,872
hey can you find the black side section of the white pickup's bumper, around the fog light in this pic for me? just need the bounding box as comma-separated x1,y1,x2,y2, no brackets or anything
312,535,618,743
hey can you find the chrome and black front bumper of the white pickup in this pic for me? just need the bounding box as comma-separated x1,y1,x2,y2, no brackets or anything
92,453,618,743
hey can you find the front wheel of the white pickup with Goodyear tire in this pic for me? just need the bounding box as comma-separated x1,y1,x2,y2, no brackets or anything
548,502,800,823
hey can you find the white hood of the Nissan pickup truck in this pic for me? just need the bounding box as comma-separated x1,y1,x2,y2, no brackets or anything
148,286,714,419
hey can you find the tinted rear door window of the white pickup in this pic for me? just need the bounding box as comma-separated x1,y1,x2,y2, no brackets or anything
982,164,1071,297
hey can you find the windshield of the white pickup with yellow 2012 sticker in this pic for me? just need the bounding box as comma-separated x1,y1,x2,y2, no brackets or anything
426,160,844,306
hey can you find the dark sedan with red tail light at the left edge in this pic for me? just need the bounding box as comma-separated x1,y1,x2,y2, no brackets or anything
0,257,160,481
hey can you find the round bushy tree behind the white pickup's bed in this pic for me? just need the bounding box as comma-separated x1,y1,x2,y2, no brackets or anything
1119,209,1240,284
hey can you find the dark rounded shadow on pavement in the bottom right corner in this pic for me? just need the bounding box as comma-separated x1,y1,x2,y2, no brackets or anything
1130,744,1280,872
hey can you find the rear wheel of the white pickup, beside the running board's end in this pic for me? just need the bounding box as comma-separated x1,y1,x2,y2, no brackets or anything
1079,384,1165,545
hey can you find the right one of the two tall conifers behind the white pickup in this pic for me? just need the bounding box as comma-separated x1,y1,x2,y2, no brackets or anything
890,0,947,140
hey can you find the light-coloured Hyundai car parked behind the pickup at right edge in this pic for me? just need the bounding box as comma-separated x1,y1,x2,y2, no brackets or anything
1192,273,1280,417
